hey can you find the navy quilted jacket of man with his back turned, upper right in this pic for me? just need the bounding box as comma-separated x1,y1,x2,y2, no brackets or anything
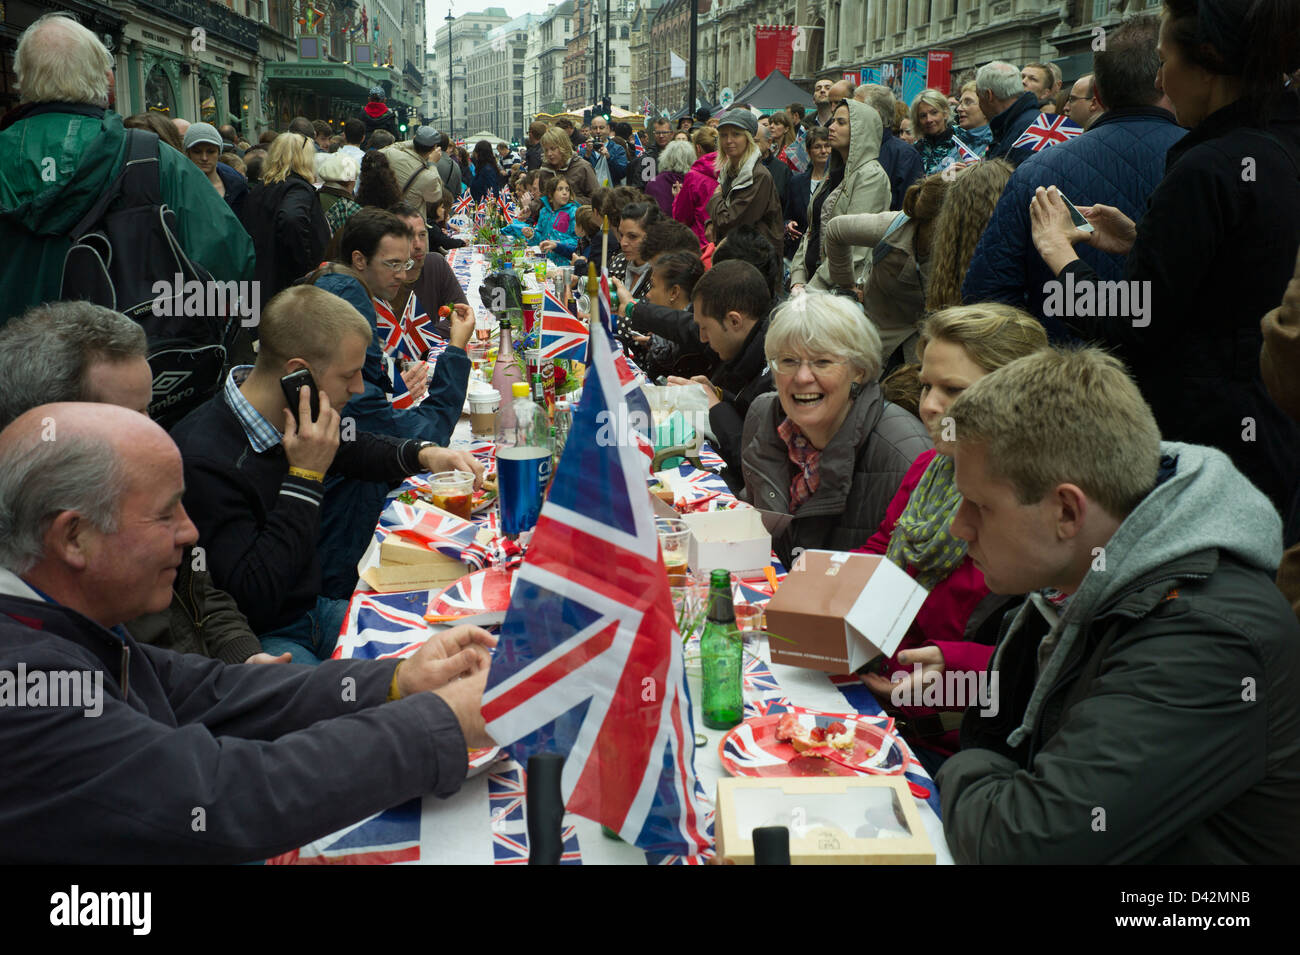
962,107,1187,340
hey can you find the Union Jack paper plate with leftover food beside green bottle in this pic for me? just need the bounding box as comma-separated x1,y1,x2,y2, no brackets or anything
718,708,907,777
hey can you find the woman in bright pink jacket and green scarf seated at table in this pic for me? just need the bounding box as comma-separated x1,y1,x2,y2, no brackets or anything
858,303,1048,767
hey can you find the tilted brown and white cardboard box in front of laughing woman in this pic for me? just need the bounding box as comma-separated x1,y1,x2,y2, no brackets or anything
764,551,928,673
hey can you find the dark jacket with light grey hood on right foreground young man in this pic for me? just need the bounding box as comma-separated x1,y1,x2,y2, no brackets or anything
937,443,1300,864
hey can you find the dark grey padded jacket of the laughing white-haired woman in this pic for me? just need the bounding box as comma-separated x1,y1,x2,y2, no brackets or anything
741,382,933,567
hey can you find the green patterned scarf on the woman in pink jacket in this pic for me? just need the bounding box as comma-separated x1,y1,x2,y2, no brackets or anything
885,455,966,590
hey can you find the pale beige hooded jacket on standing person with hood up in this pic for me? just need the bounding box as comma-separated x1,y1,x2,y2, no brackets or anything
790,100,891,291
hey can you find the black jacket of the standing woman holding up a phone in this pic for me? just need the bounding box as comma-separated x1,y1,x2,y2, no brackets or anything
1052,92,1300,527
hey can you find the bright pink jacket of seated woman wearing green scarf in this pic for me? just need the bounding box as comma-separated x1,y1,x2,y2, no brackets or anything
857,451,993,752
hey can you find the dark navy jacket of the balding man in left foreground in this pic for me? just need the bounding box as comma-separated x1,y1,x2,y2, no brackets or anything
0,589,465,865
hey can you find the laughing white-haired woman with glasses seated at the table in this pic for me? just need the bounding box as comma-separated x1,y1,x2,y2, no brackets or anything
741,291,932,565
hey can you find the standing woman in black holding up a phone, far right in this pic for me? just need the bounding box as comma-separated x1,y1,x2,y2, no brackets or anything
1031,0,1300,543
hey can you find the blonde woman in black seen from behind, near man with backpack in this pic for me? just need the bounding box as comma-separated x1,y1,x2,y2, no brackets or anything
239,133,332,305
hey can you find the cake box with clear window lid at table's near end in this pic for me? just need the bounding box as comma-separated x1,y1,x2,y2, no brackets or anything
714,776,935,865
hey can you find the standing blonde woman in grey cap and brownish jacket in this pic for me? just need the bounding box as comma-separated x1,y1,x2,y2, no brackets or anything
707,109,785,248
